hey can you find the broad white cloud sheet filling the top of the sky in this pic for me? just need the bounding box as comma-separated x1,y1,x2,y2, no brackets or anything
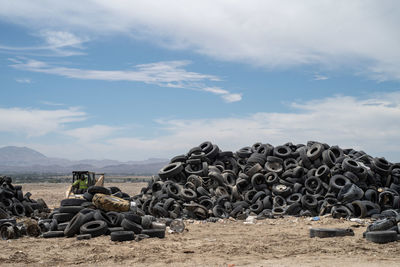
0,0,400,80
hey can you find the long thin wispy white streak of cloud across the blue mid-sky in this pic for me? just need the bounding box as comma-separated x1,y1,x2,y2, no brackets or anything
10,59,242,103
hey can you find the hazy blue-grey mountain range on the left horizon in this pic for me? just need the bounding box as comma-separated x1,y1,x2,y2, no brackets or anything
0,146,168,175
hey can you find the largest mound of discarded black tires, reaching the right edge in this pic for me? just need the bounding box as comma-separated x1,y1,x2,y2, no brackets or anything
132,141,400,220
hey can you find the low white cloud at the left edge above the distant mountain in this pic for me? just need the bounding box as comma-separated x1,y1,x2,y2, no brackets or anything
0,108,86,137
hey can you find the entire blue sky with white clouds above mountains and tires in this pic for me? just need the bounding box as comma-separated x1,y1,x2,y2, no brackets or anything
0,0,400,161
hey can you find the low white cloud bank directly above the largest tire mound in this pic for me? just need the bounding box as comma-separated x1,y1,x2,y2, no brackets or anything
14,92,400,162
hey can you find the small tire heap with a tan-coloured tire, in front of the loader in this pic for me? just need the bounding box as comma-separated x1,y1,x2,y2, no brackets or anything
43,186,166,241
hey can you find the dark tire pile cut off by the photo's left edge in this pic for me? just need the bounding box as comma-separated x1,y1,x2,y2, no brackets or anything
0,176,50,219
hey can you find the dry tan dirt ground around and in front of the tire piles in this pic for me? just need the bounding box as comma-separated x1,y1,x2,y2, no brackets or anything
0,183,400,266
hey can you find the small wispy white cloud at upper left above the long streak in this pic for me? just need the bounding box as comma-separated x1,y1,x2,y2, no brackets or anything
0,30,89,56
